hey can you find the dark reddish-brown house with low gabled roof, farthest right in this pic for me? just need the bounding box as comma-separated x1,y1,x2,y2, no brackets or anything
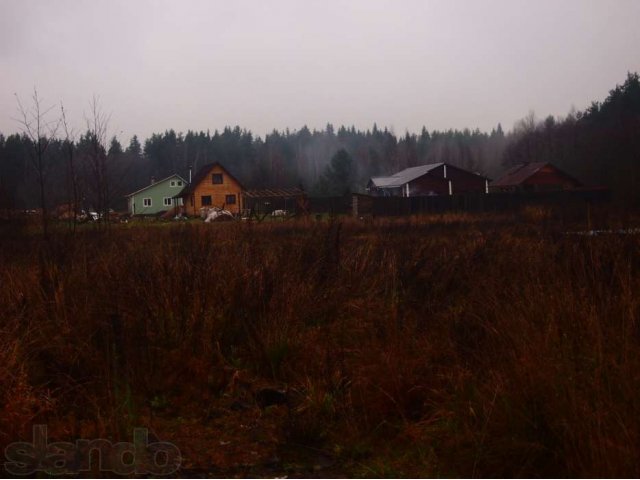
490,162,582,192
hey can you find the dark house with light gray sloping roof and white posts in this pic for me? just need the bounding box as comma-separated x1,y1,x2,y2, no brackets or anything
367,163,489,197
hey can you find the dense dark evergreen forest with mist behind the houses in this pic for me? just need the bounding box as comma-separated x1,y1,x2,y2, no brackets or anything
0,73,640,209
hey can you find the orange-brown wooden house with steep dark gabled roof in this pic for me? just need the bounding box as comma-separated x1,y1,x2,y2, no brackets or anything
179,162,245,216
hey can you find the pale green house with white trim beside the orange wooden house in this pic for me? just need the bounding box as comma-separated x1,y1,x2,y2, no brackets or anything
126,174,187,215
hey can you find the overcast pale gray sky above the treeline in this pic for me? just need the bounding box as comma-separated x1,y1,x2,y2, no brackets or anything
0,0,640,143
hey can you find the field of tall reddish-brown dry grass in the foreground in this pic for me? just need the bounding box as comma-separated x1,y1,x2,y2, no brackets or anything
0,215,640,477
